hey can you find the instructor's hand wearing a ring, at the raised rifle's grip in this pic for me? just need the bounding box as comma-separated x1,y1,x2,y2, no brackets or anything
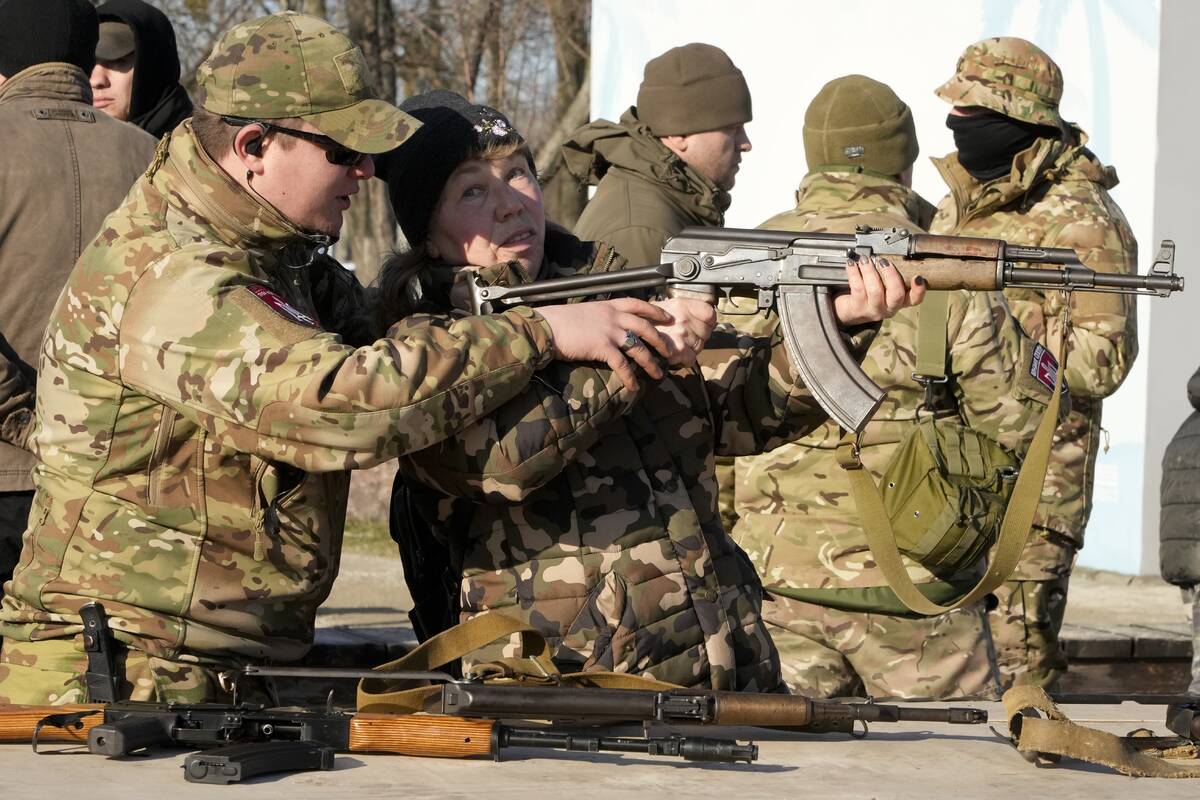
538,297,676,391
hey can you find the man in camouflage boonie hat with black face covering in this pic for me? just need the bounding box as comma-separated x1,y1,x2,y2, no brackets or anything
931,37,1138,685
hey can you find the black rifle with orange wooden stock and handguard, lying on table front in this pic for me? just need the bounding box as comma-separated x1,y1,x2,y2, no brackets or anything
0,700,758,783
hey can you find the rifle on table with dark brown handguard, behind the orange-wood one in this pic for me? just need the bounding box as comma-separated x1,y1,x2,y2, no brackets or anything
241,667,988,733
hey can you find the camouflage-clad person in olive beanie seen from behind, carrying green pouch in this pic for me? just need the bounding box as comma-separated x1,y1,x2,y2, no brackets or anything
722,76,1049,699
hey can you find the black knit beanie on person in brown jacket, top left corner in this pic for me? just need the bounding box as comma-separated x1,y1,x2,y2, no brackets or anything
0,0,100,78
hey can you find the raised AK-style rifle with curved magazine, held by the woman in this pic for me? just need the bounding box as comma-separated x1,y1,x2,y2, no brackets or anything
472,228,1183,431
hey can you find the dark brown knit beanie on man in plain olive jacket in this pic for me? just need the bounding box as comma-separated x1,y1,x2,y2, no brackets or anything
637,42,752,136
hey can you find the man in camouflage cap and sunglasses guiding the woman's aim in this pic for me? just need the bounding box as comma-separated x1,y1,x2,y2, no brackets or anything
0,12,668,704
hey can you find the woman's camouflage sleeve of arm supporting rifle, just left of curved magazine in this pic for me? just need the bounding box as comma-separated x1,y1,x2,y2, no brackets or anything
700,312,878,456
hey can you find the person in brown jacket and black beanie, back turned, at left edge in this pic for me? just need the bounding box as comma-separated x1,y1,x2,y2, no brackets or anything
0,0,155,618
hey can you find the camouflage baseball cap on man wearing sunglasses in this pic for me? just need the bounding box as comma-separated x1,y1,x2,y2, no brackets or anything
196,11,421,152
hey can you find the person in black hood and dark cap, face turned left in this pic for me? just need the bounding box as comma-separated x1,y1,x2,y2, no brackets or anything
91,0,192,138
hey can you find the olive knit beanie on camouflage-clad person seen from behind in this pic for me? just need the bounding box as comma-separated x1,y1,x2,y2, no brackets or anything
804,76,918,175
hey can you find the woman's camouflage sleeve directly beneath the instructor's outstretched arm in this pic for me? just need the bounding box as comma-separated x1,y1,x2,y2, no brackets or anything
392,318,638,503
